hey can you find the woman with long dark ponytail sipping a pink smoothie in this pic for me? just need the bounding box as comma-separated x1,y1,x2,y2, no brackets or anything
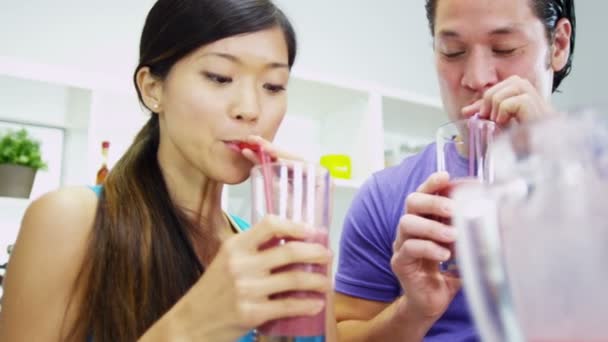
0,0,331,341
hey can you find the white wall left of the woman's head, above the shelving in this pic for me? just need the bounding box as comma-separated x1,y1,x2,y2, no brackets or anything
0,0,152,92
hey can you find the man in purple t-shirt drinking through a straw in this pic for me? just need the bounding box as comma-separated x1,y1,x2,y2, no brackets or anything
336,0,575,342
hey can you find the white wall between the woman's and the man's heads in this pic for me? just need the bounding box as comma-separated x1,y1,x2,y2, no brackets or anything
277,0,438,95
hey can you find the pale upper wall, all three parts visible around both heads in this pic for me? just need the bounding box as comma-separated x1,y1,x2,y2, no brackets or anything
0,0,608,111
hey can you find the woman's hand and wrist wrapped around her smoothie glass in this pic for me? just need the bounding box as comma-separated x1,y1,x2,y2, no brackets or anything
153,216,332,342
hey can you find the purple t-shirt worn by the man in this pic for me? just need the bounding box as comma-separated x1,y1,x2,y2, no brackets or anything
336,144,479,342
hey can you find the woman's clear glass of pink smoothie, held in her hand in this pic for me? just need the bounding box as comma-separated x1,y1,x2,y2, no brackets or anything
251,161,331,342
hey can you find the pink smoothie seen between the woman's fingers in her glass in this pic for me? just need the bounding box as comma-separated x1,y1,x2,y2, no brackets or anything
258,229,329,337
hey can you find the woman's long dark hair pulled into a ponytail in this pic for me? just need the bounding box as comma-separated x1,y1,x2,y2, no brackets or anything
69,0,296,342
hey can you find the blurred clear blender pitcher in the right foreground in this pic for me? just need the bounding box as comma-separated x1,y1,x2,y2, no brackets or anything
452,112,608,341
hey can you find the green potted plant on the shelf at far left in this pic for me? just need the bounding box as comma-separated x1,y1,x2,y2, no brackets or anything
0,128,47,198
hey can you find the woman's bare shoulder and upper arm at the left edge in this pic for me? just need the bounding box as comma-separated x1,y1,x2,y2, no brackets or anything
0,187,97,341
